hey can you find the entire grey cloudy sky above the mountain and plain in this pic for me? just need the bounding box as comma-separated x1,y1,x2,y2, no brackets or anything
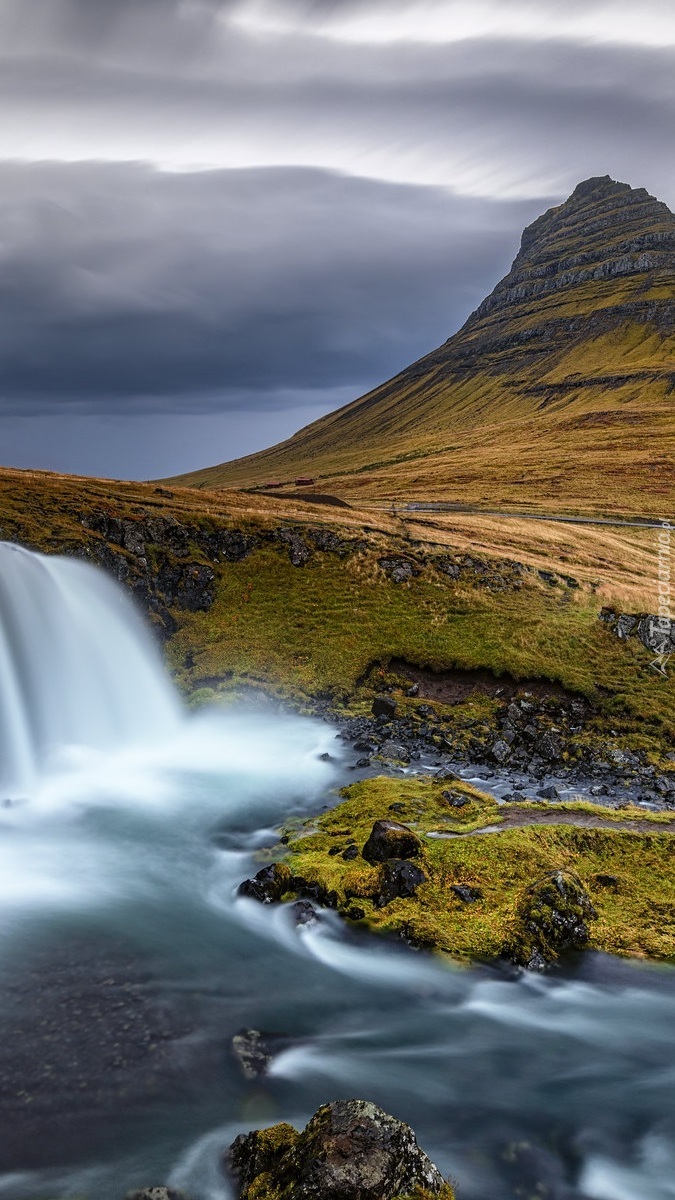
0,0,675,479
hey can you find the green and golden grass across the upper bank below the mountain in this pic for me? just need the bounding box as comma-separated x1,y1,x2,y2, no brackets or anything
0,460,675,756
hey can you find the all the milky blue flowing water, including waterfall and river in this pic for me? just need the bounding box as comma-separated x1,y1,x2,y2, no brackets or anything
0,546,675,1200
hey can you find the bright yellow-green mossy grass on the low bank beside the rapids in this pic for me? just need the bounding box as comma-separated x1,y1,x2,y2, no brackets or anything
277,778,675,961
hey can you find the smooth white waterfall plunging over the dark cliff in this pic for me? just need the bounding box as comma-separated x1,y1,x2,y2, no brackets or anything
0,542,179,798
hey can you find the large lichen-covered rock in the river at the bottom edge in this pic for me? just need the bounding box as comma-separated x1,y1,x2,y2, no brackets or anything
226,1100,453,1200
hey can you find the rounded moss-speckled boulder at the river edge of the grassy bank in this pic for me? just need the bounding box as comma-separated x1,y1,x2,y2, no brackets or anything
512,870,597,970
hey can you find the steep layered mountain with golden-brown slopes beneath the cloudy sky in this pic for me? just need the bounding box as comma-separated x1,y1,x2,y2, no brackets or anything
171,175,675,516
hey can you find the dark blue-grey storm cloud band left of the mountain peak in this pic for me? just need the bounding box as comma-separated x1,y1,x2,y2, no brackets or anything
0,164,534,413
